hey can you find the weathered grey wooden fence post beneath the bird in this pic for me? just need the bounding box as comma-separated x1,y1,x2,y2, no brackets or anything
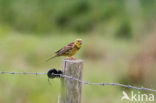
58,59,83,103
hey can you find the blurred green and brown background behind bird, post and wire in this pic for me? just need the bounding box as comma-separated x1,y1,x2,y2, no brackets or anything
0,0,156,103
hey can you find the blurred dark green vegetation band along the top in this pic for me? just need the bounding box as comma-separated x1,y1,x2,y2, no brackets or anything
0,0,156,38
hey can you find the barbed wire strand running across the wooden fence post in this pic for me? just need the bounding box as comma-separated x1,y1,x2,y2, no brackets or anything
0,71,156,92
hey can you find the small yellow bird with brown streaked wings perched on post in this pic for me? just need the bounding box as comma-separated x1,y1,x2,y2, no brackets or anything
47,39,82,61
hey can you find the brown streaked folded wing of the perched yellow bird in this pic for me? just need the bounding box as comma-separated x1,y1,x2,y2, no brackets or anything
55,42,74,55
